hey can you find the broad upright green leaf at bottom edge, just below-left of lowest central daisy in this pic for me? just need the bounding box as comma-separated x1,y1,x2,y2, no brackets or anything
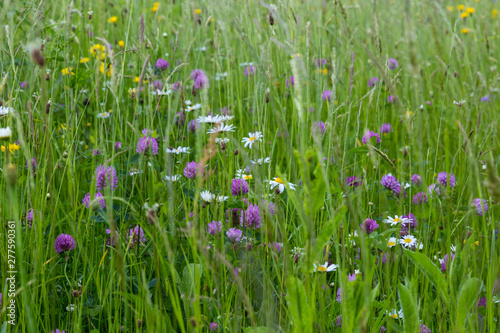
286,276,313,332
